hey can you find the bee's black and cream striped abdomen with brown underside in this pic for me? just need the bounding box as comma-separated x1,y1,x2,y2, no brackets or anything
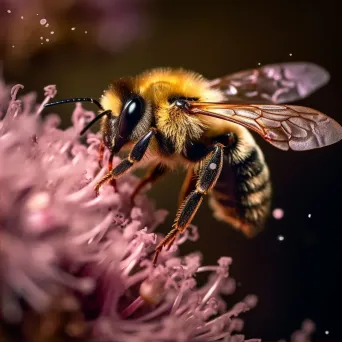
210,145,272,237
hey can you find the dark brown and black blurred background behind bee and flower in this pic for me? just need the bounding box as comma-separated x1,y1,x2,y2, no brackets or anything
0,0,342,341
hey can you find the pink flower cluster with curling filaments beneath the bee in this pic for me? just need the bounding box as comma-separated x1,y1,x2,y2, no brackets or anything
0,83,257,342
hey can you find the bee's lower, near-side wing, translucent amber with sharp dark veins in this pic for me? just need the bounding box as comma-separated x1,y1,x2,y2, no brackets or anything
189,102,342,151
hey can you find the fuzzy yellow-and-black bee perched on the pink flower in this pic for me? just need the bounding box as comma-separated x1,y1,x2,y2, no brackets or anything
45,62,342,264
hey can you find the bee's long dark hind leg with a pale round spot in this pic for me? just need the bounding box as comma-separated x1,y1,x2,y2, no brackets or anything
152,144,224,265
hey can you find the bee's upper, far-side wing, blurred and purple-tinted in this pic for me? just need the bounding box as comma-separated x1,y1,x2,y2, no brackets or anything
209,62,330,103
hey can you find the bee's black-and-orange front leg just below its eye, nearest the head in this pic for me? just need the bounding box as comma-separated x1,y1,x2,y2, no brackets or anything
95,128,157,194
